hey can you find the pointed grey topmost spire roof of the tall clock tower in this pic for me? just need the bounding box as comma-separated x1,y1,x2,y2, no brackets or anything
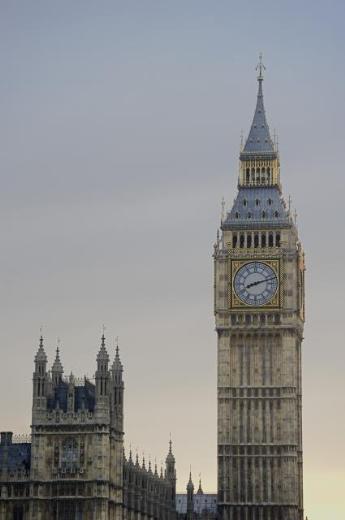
240,54,276,159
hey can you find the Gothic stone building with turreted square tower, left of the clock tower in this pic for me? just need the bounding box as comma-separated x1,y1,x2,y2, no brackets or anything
0,335,176,520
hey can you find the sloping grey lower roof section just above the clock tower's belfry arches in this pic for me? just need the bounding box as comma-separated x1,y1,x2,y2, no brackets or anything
222,186,291,229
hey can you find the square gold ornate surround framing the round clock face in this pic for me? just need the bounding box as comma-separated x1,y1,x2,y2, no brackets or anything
228,258,282,312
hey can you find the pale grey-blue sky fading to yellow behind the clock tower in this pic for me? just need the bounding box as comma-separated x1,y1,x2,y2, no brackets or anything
0,0,345,520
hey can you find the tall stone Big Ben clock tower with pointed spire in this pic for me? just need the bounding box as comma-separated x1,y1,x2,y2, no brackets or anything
214,57,305,520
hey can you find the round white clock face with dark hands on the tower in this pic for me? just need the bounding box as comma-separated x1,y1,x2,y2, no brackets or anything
234,262,278,306
